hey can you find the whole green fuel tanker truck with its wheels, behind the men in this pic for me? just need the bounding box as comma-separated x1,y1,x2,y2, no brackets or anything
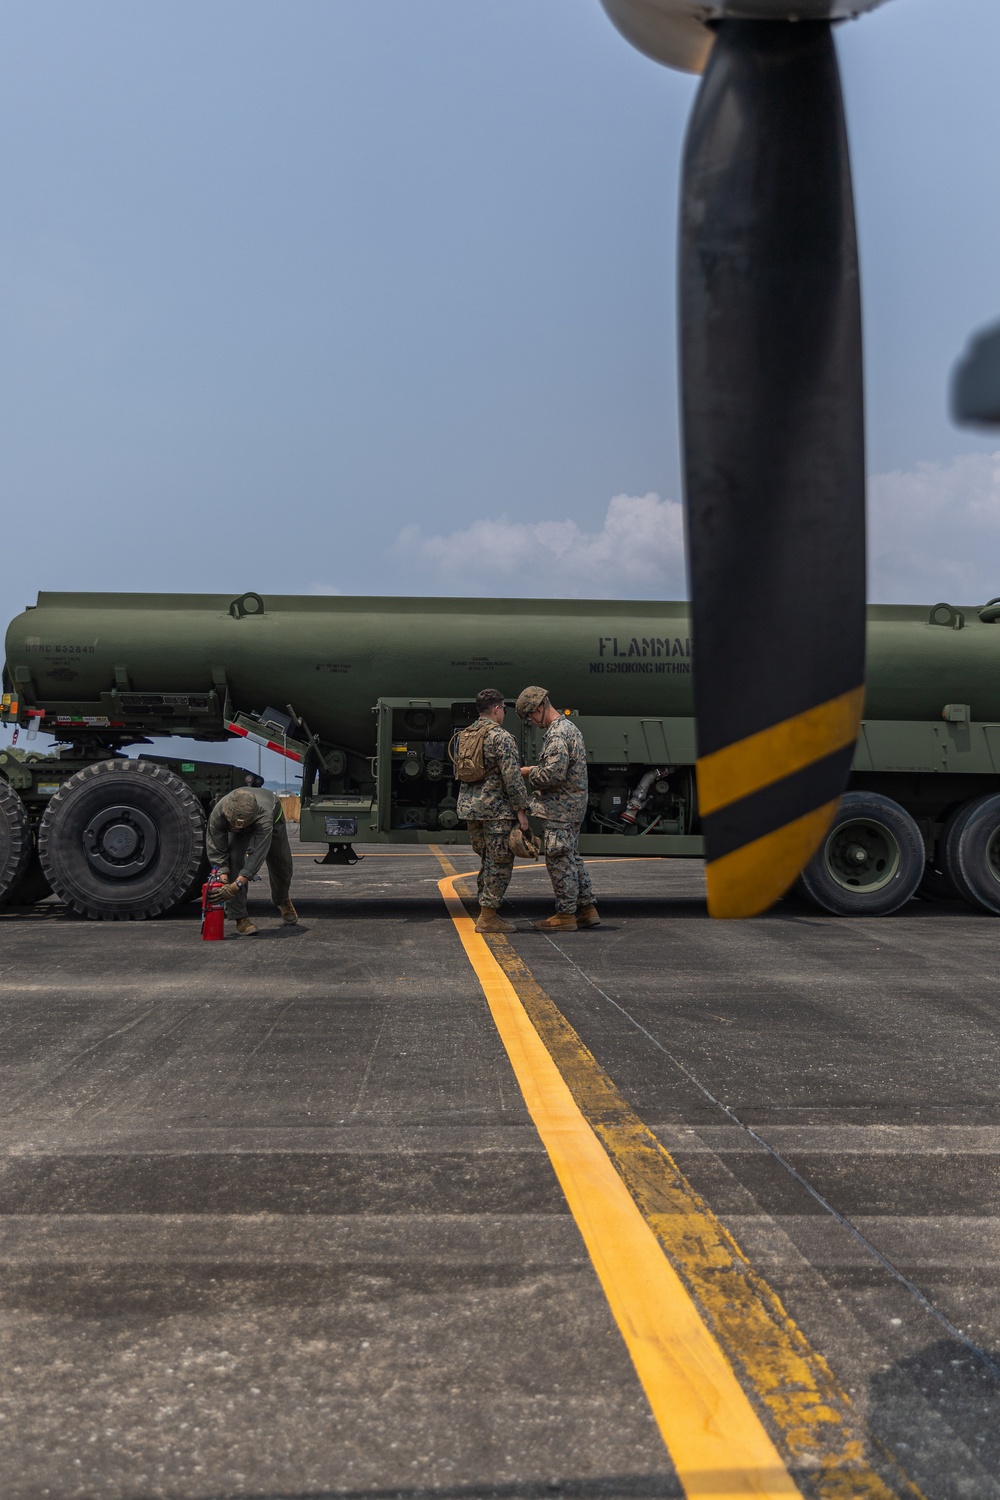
0,593,1000,918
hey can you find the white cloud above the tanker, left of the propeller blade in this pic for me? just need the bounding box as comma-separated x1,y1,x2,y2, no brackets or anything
393,494,685,599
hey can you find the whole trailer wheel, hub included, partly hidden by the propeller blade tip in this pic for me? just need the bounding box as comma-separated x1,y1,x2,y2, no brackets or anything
799,792,927,917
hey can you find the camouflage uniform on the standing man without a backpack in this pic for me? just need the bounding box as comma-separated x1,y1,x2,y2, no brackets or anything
528,719,594,912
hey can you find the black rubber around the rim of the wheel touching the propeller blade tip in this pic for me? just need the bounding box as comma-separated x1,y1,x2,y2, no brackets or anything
798,792,927,917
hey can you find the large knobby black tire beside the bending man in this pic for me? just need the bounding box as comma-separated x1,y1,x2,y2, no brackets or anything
37,759,205,921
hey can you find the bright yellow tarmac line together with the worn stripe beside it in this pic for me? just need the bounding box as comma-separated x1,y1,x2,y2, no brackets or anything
438,861,919,1500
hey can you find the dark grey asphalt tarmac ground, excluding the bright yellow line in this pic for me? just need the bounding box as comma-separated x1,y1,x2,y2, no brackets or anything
0,846,1000,1500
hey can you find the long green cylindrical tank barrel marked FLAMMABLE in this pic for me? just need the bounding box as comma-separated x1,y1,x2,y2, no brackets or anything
4,594,1000,744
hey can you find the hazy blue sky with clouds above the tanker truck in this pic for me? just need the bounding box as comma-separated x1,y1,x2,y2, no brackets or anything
0,0,1000,768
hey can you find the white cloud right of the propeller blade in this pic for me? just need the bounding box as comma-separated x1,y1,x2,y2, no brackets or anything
868,453,1000,605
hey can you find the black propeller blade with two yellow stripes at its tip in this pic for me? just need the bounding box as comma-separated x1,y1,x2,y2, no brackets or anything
681,21,865,917
